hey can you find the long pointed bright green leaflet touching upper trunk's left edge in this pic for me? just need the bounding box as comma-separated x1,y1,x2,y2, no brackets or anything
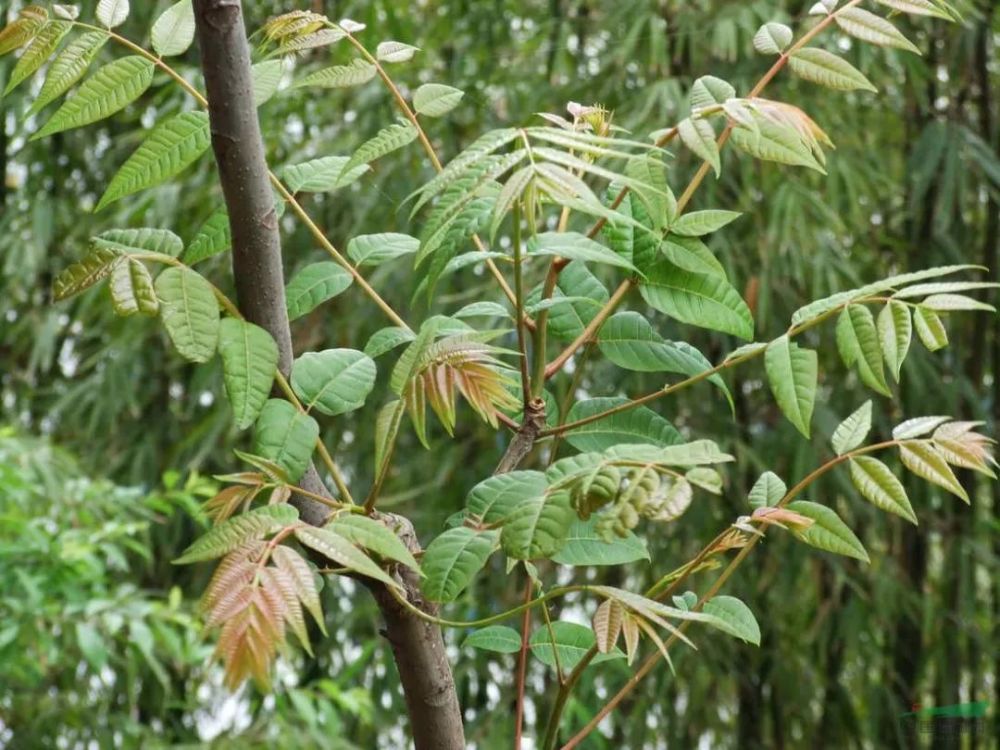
94,112,212,211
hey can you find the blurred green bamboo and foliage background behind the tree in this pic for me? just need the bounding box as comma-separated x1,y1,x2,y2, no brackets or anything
0,0,1000,750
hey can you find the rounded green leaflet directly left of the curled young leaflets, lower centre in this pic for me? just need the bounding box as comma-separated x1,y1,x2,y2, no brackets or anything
500,491,576,560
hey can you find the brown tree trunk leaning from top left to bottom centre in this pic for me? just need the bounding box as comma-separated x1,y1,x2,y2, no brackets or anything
194,0,465,750
